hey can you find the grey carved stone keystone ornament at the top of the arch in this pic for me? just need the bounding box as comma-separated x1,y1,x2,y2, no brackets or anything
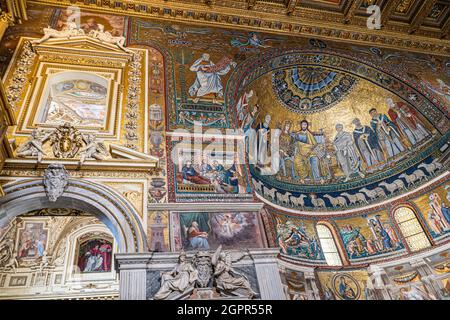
44,163,69,202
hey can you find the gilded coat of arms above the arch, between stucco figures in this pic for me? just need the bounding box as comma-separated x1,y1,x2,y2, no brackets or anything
50,122,83,158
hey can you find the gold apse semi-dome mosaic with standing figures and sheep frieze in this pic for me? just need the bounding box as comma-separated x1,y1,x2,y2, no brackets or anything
227,50,449,212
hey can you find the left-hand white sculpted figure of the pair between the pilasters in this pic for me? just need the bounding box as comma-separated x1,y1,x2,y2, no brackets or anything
153,251,198,300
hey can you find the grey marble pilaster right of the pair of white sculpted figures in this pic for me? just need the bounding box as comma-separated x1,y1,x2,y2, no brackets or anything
250,248,286,300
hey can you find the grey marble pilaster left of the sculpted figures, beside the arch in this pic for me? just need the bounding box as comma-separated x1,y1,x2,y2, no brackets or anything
115,253,149,300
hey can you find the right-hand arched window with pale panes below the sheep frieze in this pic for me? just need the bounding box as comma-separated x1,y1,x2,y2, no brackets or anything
394,207,431,251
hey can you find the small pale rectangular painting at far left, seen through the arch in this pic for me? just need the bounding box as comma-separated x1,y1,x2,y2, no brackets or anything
17,222,48,259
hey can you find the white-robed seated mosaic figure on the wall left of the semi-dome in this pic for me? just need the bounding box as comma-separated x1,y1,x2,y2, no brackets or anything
189,53,236,104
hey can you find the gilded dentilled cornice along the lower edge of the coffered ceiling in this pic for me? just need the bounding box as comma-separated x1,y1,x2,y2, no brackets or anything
29,0,450,56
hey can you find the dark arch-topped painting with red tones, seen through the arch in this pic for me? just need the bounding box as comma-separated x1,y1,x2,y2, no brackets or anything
78,239,113,272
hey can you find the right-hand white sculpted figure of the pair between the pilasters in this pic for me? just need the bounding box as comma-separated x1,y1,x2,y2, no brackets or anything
211,245,257,299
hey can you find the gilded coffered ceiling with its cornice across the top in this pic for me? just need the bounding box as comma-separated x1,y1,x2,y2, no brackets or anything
14,0,450,55
